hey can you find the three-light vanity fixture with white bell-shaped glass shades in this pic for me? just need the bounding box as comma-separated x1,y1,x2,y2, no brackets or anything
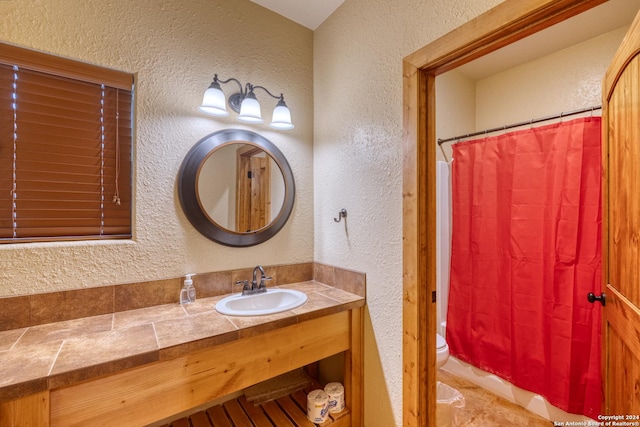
198,74,294,130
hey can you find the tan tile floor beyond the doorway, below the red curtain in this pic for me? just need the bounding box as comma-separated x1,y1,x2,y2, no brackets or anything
437,369,553,427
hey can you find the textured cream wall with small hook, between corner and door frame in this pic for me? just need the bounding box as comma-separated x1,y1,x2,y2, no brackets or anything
314,0,500,427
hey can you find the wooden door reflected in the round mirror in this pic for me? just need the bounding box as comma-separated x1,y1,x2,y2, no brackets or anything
236,146,271,233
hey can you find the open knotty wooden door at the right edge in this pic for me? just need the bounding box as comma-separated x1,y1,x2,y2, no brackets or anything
602,8,640,416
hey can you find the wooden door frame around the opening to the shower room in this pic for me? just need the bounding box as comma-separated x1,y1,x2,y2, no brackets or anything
402,0,608,427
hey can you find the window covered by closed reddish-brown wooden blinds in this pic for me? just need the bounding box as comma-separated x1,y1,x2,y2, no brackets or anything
0,43,133,243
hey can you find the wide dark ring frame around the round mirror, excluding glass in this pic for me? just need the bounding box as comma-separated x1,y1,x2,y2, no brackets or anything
178,129,296,247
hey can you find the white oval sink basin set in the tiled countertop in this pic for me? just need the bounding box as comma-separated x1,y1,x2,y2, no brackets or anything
216,289,307,316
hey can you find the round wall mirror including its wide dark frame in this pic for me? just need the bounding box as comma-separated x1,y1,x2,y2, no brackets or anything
178,129,295,247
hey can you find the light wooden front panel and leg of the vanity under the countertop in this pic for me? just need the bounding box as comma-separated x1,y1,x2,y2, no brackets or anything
0,307,363,427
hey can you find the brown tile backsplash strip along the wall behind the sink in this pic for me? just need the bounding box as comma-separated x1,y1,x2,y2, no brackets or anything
0,262,366,331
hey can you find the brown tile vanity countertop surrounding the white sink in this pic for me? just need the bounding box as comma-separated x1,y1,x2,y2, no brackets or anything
0,281,365,403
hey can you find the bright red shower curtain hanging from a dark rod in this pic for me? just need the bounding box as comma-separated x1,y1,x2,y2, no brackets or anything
447,117,601,418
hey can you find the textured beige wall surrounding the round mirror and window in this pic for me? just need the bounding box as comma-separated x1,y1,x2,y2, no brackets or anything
0,0,313,296
